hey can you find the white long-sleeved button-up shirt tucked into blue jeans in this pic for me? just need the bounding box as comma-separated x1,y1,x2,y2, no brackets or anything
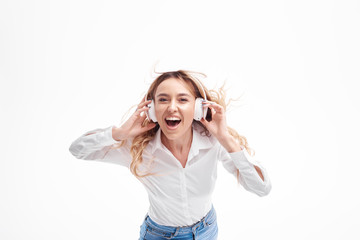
69,124,271,226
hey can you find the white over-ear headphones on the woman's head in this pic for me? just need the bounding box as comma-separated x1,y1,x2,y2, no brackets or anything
145,78,208,122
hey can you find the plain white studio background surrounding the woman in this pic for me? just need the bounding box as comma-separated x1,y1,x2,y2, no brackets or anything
0,0,360,240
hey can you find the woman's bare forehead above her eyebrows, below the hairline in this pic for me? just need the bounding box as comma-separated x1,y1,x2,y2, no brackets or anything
155,78,195,96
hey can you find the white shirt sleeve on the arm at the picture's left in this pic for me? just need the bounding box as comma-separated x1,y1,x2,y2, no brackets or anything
69,126,131,167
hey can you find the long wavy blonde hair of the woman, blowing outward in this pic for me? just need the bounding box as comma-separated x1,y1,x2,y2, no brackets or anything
114,70,255,182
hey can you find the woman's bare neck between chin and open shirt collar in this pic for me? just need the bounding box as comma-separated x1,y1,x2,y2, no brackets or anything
161,128,193,153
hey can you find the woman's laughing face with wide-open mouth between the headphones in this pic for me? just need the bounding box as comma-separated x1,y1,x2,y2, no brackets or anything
155,78,195,140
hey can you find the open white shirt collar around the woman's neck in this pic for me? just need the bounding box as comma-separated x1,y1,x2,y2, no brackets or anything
151,124,214,155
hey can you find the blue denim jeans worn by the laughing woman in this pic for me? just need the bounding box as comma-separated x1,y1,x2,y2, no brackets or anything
139,207,218,240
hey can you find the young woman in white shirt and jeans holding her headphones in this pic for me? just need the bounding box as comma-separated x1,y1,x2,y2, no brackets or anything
70,70,271,240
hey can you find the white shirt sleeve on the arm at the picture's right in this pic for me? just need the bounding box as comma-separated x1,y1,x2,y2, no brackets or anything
219,146,271,197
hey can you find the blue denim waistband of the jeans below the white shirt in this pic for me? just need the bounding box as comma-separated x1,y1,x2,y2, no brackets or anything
145,206,216,234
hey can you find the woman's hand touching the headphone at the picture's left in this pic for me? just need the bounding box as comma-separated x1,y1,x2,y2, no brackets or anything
112,97,156,141
